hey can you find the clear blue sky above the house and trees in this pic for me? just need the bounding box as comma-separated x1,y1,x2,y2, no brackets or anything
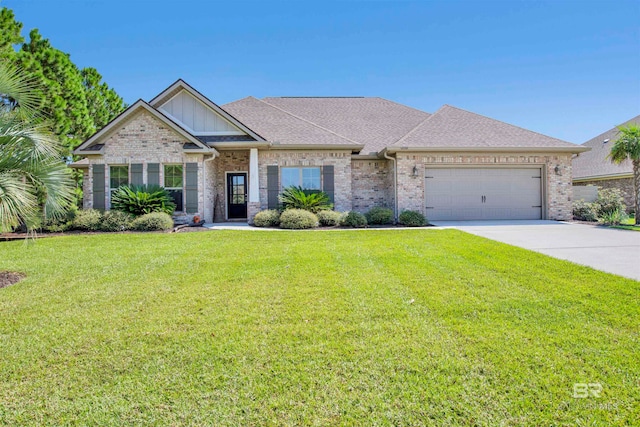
5,0,640,143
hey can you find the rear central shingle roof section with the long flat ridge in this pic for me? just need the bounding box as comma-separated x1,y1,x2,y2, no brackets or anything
258,97,430,154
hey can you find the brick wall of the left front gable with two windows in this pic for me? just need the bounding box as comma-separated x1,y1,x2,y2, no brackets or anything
83,111,204,214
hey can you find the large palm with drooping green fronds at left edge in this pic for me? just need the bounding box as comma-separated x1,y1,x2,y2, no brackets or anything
0,63,74,232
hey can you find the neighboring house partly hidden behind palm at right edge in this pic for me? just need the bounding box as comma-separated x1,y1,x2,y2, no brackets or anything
573,116,640,208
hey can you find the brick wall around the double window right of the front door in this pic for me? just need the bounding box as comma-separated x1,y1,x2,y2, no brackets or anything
258,150,352,212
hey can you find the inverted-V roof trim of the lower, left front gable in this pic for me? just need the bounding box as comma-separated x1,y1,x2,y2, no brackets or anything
73,99,216,155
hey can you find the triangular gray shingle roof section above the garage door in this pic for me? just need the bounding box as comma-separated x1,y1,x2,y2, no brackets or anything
393,105,576,149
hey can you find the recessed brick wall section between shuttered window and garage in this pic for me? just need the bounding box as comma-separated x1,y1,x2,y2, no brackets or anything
351,160,394,213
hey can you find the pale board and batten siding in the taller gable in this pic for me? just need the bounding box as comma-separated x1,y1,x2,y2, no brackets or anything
159,90,244,135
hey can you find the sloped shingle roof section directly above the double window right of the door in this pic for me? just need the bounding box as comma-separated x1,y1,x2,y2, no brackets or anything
222,96,360,148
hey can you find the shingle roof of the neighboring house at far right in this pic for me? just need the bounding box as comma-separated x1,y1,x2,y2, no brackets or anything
573,115,640,179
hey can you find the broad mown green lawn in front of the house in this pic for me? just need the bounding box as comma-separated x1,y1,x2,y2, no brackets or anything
0,229,640,426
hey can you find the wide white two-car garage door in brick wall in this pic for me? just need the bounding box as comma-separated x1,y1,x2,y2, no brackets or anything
425,168,542,221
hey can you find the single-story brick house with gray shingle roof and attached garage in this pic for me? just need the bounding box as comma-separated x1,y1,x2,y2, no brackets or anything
72,80,586,222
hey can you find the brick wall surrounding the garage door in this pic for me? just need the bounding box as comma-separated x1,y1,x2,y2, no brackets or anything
397,153,572,220
